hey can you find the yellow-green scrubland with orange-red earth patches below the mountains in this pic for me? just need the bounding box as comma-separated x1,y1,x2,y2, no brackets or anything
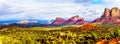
0,24,120,44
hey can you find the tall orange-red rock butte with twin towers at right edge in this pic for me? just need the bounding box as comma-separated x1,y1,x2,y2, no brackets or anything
93,7,120,24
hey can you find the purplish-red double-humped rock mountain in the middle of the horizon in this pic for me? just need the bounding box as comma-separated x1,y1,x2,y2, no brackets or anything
52,15,85,25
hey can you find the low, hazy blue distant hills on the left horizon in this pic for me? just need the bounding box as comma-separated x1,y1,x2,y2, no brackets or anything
0,20,52,27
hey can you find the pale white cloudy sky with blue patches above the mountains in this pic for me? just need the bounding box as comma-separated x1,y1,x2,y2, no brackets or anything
0,0,120,21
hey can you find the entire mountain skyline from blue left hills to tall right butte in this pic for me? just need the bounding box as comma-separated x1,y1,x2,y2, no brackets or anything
0,7,120,27
